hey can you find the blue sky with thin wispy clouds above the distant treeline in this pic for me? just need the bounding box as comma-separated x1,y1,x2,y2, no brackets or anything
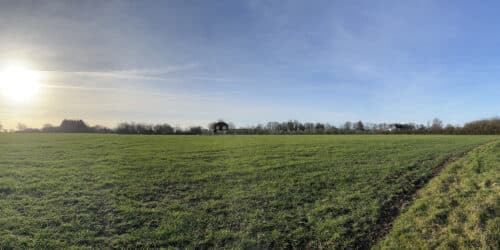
0,0,500,128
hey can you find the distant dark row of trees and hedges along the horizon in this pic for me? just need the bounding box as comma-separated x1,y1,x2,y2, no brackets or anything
0,118,500,135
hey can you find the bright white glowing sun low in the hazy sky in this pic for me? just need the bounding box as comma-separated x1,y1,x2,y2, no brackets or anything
0,65,40,103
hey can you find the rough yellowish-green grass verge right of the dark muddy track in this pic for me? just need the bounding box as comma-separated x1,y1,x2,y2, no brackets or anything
379,142,500,249
